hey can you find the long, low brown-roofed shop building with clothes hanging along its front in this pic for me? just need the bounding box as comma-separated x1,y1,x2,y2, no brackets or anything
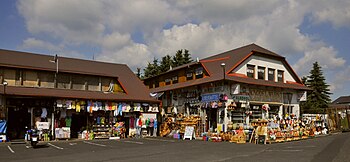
0,50,159,139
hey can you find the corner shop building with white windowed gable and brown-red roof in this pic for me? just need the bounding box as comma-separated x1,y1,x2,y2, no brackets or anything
144,44,309,134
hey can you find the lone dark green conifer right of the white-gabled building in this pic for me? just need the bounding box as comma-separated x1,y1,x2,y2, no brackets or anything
301,62,332,113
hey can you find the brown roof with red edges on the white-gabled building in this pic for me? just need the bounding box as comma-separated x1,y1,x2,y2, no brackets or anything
151,44,310,92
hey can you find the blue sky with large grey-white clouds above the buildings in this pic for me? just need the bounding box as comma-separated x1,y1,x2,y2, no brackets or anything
0,0,350,99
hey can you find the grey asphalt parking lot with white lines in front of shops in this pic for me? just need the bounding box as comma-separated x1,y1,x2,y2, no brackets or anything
0,133,350,162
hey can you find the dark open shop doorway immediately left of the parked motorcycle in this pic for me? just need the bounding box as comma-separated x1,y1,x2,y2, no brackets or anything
7,107,31,140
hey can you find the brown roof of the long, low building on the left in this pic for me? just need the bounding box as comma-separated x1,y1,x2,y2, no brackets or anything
0,49,158,102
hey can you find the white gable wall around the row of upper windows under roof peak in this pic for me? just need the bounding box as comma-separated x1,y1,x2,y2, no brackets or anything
233,56,296,83
